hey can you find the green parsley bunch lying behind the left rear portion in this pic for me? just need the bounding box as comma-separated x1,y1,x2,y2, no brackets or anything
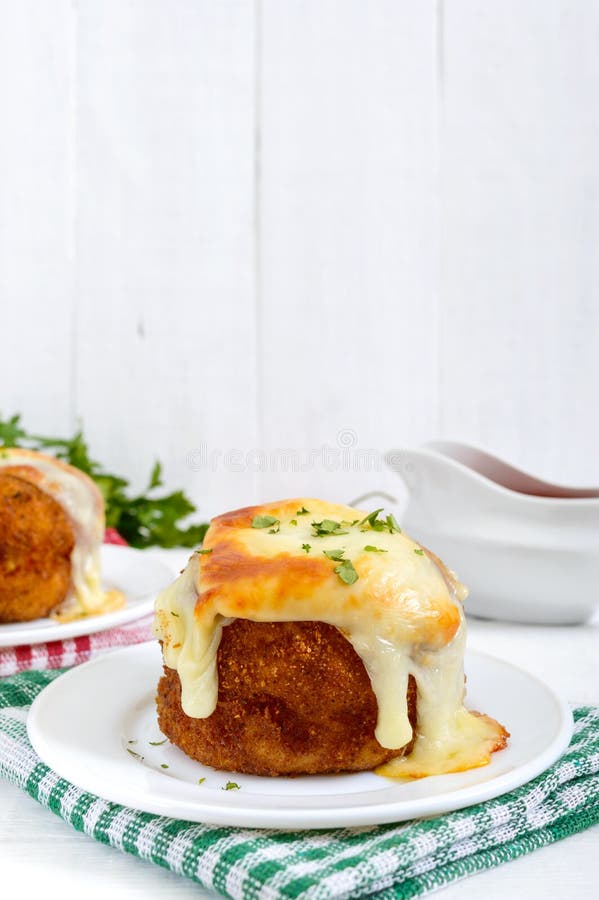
0,415,208,548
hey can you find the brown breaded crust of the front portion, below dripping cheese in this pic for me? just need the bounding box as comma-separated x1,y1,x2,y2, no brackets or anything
157,619,416,775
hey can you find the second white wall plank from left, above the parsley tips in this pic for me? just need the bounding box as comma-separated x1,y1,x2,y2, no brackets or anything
75,0,256,506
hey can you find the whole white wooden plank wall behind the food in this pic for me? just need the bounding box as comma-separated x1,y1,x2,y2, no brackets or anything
0,0,599,513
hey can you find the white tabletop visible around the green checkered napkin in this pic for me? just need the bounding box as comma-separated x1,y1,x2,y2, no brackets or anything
0,552,599,900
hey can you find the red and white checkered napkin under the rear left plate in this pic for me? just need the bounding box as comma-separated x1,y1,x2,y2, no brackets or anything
0,528,152,676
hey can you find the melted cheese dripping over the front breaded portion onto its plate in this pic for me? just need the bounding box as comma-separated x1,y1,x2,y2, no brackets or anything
154,499,505,778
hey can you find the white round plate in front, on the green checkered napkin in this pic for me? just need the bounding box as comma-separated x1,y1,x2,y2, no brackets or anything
27,642,572,829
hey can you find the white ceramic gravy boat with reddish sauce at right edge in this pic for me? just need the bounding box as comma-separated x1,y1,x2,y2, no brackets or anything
387,441,599,624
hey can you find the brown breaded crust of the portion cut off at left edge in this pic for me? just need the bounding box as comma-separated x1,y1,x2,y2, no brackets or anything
0,474,74,622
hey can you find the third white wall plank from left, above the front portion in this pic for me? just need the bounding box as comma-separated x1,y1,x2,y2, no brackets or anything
259,0,438,499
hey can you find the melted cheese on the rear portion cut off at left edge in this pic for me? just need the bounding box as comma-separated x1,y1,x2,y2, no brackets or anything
0,448,125,622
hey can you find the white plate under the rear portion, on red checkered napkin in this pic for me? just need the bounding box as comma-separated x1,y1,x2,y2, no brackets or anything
0,544,173,647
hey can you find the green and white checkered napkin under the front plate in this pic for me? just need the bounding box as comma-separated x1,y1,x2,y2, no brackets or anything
0,670,599,900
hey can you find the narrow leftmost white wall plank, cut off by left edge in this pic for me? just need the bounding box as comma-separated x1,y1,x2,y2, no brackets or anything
0,0,74,432
